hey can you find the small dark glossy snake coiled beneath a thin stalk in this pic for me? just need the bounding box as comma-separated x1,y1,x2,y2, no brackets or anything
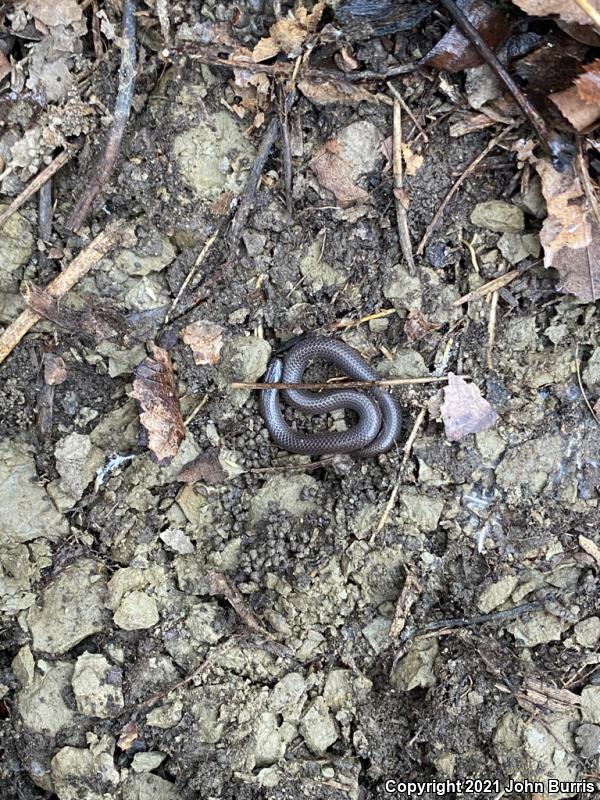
260,336,402,458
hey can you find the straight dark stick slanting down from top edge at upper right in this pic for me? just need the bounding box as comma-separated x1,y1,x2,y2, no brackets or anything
438,0,572,172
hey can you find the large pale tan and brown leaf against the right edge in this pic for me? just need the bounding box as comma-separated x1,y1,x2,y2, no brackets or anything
536,160,600,302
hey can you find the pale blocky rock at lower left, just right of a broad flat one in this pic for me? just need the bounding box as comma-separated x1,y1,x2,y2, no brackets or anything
71,652,124,719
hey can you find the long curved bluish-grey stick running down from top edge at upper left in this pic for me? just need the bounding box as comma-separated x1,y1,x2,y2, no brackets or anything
66,0,136,231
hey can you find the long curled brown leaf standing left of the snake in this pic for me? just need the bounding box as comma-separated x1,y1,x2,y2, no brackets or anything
132,342,185,466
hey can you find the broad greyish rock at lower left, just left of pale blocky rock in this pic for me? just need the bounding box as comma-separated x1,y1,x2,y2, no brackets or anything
17,661,75,736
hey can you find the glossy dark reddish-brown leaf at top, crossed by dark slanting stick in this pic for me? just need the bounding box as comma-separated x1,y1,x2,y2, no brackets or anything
422,0,511,72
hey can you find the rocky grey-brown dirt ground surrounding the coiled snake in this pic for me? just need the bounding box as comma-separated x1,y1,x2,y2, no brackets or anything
0,2,600,800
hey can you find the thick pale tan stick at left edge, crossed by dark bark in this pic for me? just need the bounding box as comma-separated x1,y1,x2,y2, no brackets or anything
0,222,125,364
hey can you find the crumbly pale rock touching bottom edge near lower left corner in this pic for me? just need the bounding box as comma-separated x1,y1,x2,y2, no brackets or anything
51,734,119,800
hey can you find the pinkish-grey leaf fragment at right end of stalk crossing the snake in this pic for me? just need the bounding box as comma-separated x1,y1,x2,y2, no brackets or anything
440,373,498,442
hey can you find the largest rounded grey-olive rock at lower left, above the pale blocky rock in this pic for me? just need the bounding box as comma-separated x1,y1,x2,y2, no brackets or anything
27,558,107,655
